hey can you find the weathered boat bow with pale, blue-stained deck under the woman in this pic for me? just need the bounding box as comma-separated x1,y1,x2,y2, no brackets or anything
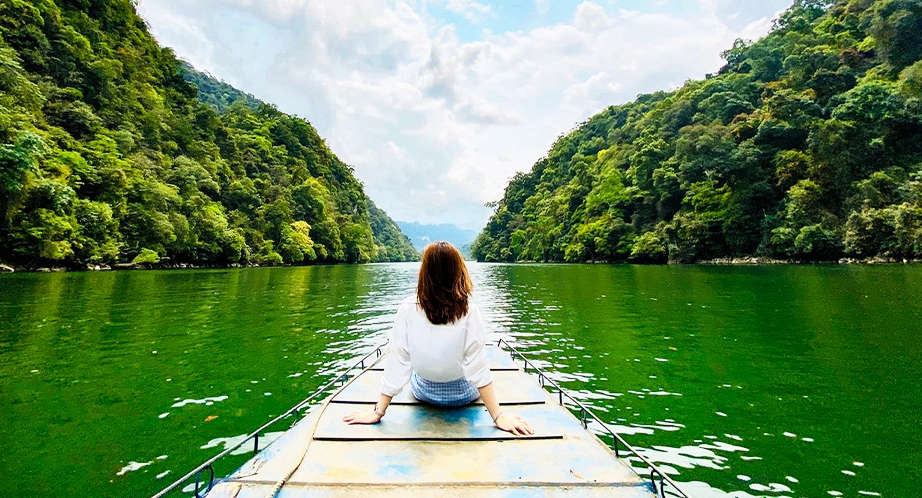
154,339,688,498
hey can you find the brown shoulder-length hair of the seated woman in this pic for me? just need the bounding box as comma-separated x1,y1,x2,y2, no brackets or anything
416,242,474,325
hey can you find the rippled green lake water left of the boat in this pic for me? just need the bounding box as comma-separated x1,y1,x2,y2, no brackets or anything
0,265,416,496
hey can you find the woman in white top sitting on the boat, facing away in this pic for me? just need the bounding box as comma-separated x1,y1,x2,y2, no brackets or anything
343,242,534,436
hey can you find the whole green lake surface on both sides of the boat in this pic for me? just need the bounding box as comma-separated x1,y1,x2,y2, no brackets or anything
0,264,922,498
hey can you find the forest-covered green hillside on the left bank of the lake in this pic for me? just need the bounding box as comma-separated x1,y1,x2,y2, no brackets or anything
0,0,417,268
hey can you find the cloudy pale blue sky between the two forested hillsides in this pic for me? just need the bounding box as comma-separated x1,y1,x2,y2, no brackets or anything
138,0,792,230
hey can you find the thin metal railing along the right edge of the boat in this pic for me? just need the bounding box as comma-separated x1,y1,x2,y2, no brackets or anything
496,339,689,498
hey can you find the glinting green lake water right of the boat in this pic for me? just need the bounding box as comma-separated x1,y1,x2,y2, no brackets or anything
475,265,922,497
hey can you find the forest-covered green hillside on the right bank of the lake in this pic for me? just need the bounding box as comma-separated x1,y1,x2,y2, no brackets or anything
473,0,922,262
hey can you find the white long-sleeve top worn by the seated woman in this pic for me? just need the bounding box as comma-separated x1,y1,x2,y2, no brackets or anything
381,296,493,396
